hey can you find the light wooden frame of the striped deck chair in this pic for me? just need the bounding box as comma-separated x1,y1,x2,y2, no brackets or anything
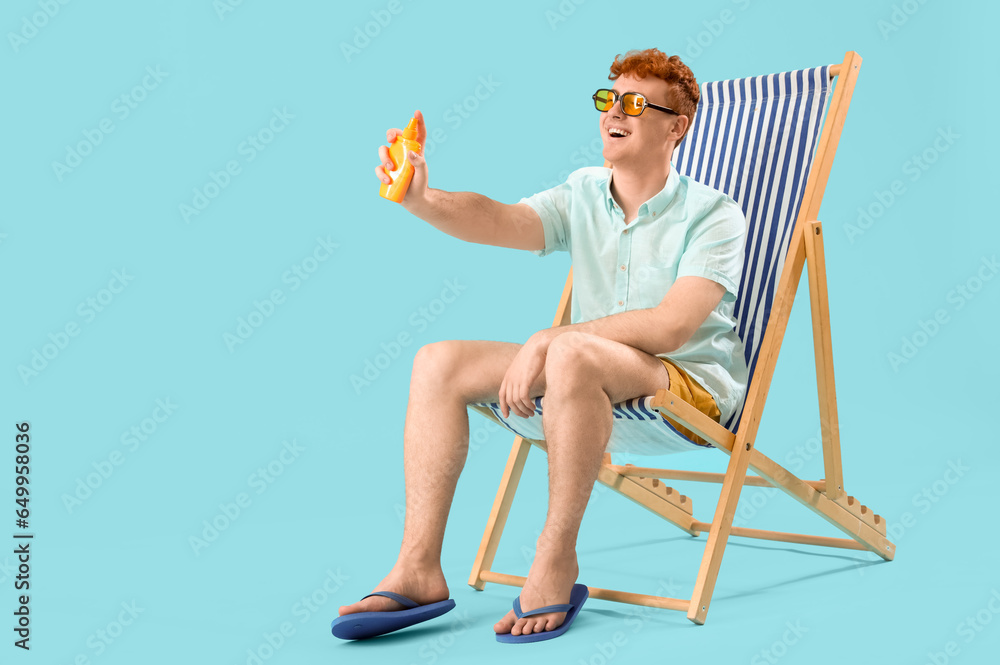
469,51,895,624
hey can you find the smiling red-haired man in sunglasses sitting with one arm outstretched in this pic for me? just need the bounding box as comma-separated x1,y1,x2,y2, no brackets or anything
335,49,747,638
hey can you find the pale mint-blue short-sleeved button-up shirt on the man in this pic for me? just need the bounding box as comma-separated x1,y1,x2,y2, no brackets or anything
520,164,748,424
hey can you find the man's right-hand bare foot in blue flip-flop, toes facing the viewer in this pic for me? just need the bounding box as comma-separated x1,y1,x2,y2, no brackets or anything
493,550,580,635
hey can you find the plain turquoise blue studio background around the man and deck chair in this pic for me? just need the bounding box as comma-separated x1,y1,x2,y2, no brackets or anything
0,0,1000,665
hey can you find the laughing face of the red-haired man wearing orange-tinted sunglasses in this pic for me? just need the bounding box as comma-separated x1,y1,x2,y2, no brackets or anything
600,74,679,165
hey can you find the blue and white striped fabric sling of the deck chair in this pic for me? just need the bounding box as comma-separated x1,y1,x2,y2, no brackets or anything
475,66,830,455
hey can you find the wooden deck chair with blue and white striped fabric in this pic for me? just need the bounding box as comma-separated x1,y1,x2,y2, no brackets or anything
469,51,895,624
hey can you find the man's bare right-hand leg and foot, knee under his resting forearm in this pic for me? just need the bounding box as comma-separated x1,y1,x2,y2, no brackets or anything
493,332,670,635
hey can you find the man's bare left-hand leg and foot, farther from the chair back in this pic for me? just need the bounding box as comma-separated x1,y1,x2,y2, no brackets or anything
340,340,545,615
